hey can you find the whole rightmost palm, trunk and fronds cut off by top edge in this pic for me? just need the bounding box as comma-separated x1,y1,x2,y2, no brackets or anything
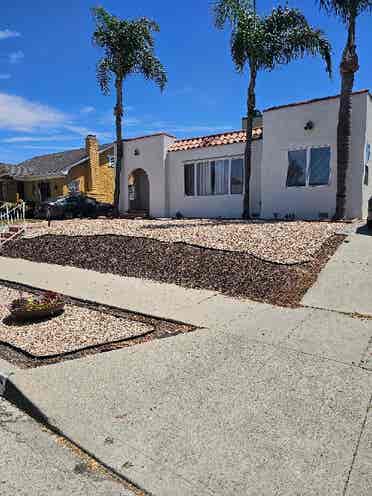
318,0,372,220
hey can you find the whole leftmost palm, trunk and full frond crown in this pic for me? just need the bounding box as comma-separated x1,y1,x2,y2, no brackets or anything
92,7,167,215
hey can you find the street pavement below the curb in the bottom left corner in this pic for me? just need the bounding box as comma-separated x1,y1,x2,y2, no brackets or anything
0,398,136,496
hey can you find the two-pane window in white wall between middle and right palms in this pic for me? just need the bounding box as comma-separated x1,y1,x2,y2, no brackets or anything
286,146,331,188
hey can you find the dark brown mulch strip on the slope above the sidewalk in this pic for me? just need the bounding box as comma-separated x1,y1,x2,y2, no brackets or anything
3,235,345,306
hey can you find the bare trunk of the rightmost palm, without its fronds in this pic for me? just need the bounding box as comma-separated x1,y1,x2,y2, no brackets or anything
334,17,359,220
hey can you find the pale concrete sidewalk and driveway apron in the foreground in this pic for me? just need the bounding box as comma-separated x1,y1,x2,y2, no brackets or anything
0,254,372,496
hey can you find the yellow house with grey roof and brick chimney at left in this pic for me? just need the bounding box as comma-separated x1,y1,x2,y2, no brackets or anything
0,135,115,203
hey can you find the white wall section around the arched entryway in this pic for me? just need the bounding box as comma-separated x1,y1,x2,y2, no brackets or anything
120,134,174,217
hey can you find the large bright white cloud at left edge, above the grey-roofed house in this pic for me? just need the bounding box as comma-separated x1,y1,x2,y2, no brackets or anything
0,93,67,132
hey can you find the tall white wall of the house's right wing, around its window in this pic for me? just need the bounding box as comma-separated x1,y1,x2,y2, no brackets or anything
261,93,368,219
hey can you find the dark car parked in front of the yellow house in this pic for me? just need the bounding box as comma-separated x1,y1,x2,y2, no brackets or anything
35,194,113,219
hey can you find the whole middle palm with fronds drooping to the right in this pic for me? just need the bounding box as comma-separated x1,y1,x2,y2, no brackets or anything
214,0,332,219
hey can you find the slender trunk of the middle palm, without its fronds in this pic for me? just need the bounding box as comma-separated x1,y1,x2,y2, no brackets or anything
243,64,257,219
